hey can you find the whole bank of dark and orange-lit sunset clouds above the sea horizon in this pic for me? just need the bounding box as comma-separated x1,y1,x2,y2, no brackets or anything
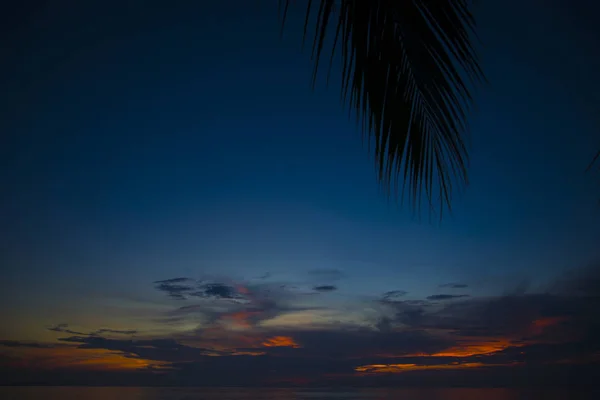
7,268,600,386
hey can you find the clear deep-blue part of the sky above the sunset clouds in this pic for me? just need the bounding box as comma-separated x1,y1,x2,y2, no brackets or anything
0,0,600,346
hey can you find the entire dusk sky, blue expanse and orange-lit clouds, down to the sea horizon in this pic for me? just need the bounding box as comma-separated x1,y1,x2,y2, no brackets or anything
0,0,600,386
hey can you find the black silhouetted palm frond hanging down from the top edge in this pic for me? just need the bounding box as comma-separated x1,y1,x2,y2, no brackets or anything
280,0,483,218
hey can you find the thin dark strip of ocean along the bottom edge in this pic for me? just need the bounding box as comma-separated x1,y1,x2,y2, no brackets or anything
0,387,600,400
